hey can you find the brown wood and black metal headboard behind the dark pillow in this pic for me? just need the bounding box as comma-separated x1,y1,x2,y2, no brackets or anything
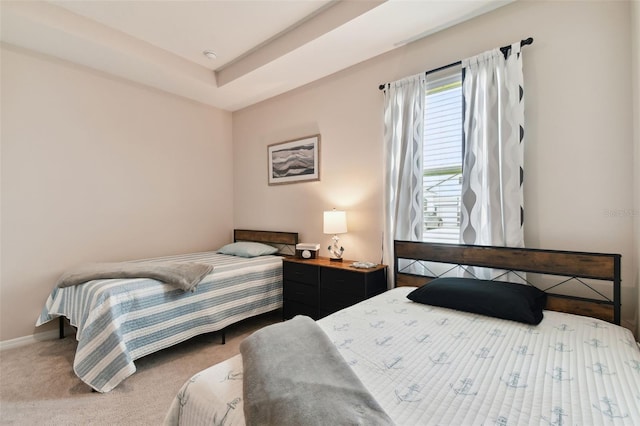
394,241,621,325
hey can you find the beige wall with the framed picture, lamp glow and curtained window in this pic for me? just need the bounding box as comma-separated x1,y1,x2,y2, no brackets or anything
233,1,637,327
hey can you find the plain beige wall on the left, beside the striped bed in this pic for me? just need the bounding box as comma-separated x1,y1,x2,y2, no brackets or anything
0,46,233,341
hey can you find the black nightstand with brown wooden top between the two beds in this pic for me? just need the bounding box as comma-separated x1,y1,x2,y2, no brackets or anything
282,257,387,319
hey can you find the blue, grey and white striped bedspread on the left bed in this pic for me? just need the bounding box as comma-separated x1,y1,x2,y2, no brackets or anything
36,252,282,392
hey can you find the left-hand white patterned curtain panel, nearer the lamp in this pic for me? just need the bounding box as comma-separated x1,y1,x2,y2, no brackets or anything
382,73,425,287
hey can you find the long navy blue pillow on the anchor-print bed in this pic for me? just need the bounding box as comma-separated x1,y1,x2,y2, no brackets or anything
407,277,547,325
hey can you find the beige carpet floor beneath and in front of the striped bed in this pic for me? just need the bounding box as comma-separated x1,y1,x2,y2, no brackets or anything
0,311,282,425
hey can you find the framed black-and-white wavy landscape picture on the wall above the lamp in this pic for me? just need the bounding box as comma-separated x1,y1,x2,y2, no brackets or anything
267,135,320,185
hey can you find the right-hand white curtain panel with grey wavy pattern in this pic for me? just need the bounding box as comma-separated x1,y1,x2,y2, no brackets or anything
460,43,524,278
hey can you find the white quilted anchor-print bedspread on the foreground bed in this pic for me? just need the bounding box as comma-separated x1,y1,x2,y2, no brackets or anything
165,287,640,425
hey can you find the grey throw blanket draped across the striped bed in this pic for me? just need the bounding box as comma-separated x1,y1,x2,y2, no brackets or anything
56,262,213,291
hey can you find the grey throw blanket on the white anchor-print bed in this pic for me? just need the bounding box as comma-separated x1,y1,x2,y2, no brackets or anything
240,316,393,426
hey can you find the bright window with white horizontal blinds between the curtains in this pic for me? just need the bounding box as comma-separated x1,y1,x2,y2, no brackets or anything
422,66,463,243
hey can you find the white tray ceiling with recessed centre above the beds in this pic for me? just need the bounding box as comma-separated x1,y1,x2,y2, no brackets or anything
0,0,513,111
